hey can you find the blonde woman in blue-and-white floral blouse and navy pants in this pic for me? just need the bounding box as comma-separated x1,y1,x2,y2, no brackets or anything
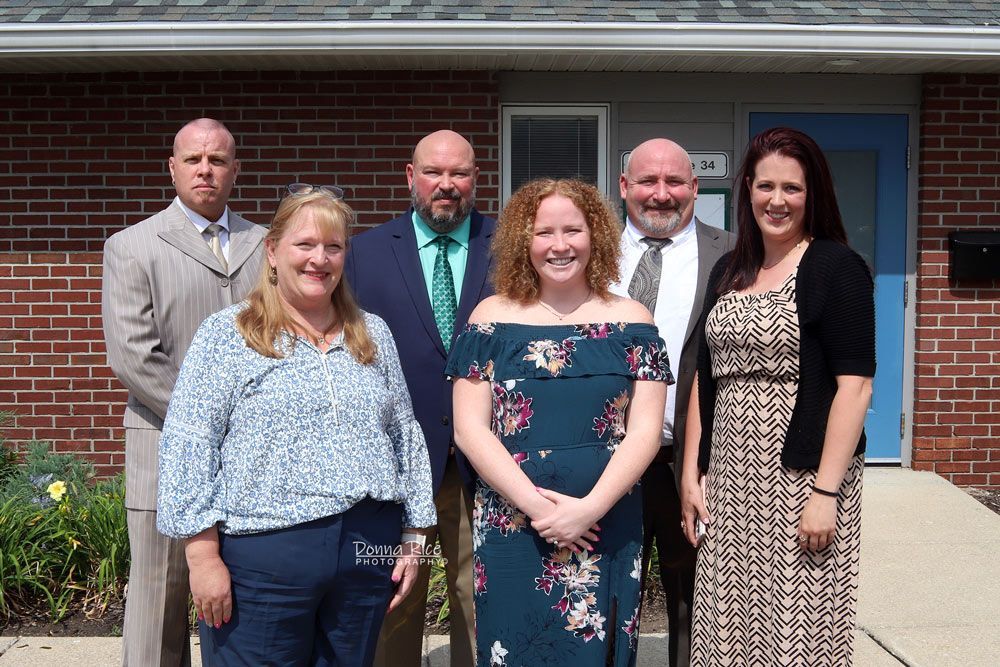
158,184,436,665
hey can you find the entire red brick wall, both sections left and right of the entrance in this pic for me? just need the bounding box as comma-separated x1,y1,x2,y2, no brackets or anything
0,71,1000,486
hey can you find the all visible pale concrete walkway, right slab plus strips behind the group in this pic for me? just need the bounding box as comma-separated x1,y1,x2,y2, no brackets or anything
0,468,1000,667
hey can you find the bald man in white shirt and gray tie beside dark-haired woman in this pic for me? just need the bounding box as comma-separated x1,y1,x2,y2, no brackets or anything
611,139,735,667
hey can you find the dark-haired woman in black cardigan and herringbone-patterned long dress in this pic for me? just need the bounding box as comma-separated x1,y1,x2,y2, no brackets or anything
681,128,875,667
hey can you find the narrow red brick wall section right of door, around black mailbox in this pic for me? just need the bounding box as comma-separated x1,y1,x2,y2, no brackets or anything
913,75,1000,486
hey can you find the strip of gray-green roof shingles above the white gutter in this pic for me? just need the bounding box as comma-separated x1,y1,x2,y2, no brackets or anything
0,0,1000,26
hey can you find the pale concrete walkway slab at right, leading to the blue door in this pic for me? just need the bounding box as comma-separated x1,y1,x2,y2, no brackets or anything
858,468,1000,667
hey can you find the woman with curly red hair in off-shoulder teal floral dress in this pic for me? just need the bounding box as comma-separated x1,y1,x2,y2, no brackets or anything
447,180,672,667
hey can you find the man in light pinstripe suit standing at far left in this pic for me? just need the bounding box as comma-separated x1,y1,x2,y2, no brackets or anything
101,118,265,667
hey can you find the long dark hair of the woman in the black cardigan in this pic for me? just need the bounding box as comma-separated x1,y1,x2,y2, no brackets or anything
719,127,847,294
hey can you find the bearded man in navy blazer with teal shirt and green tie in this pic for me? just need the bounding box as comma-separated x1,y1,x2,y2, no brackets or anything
344,130,496,667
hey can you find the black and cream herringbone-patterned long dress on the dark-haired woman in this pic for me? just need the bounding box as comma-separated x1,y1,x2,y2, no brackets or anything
691,274,863,667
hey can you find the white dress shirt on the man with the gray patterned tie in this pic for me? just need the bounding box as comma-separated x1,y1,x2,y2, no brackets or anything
610,219,698,445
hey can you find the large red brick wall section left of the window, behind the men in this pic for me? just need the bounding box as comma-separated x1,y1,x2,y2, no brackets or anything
0,71,499,474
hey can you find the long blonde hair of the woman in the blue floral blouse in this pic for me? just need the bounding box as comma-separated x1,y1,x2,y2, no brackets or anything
236,191,378,365
